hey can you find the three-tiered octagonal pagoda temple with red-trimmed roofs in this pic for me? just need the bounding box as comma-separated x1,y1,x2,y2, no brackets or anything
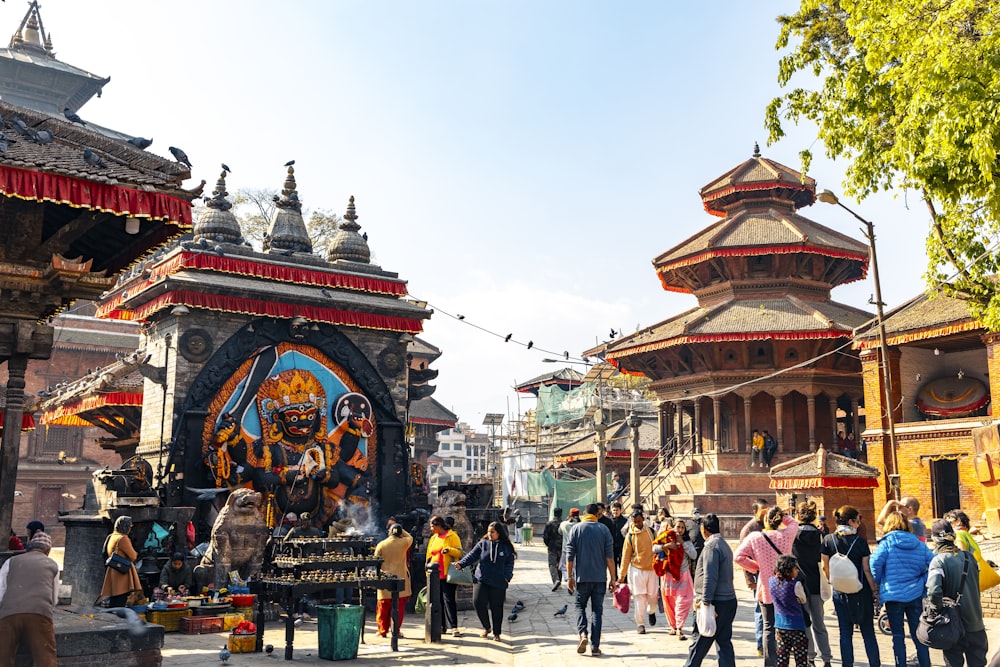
585,146,870,511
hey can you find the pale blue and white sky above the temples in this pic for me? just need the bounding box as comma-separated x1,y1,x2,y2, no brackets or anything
19,0,928,432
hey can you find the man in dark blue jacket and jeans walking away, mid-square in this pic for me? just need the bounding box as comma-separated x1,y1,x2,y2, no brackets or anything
566,503,615,655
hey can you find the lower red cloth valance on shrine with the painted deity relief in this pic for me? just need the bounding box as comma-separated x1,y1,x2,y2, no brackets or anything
104,290,423,333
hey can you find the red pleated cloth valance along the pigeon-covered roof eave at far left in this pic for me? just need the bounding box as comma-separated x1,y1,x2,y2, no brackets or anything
0,166,191,228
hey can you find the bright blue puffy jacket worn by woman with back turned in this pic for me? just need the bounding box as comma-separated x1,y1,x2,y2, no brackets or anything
868,530,934,602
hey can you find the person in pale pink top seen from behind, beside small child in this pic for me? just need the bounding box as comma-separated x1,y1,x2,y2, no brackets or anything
733,507,799,667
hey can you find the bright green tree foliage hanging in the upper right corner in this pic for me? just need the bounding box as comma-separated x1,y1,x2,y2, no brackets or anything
766,0,1000,331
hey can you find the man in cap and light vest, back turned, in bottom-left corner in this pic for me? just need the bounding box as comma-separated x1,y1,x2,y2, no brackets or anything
0,531,59,667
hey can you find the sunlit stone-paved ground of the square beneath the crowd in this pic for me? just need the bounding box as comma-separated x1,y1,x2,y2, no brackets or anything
163,546,1000,667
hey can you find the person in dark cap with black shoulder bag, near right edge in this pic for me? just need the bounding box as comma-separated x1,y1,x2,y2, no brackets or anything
927,519,989,667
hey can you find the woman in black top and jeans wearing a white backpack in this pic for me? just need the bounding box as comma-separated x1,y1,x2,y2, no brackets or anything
823,505,882,667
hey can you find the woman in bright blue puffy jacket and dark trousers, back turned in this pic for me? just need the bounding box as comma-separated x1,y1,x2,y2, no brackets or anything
869,512,934,667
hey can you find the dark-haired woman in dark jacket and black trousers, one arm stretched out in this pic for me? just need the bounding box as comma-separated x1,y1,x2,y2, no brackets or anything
455,521,517,641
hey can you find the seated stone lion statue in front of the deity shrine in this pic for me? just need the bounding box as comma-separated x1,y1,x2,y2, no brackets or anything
194,489,269,590
